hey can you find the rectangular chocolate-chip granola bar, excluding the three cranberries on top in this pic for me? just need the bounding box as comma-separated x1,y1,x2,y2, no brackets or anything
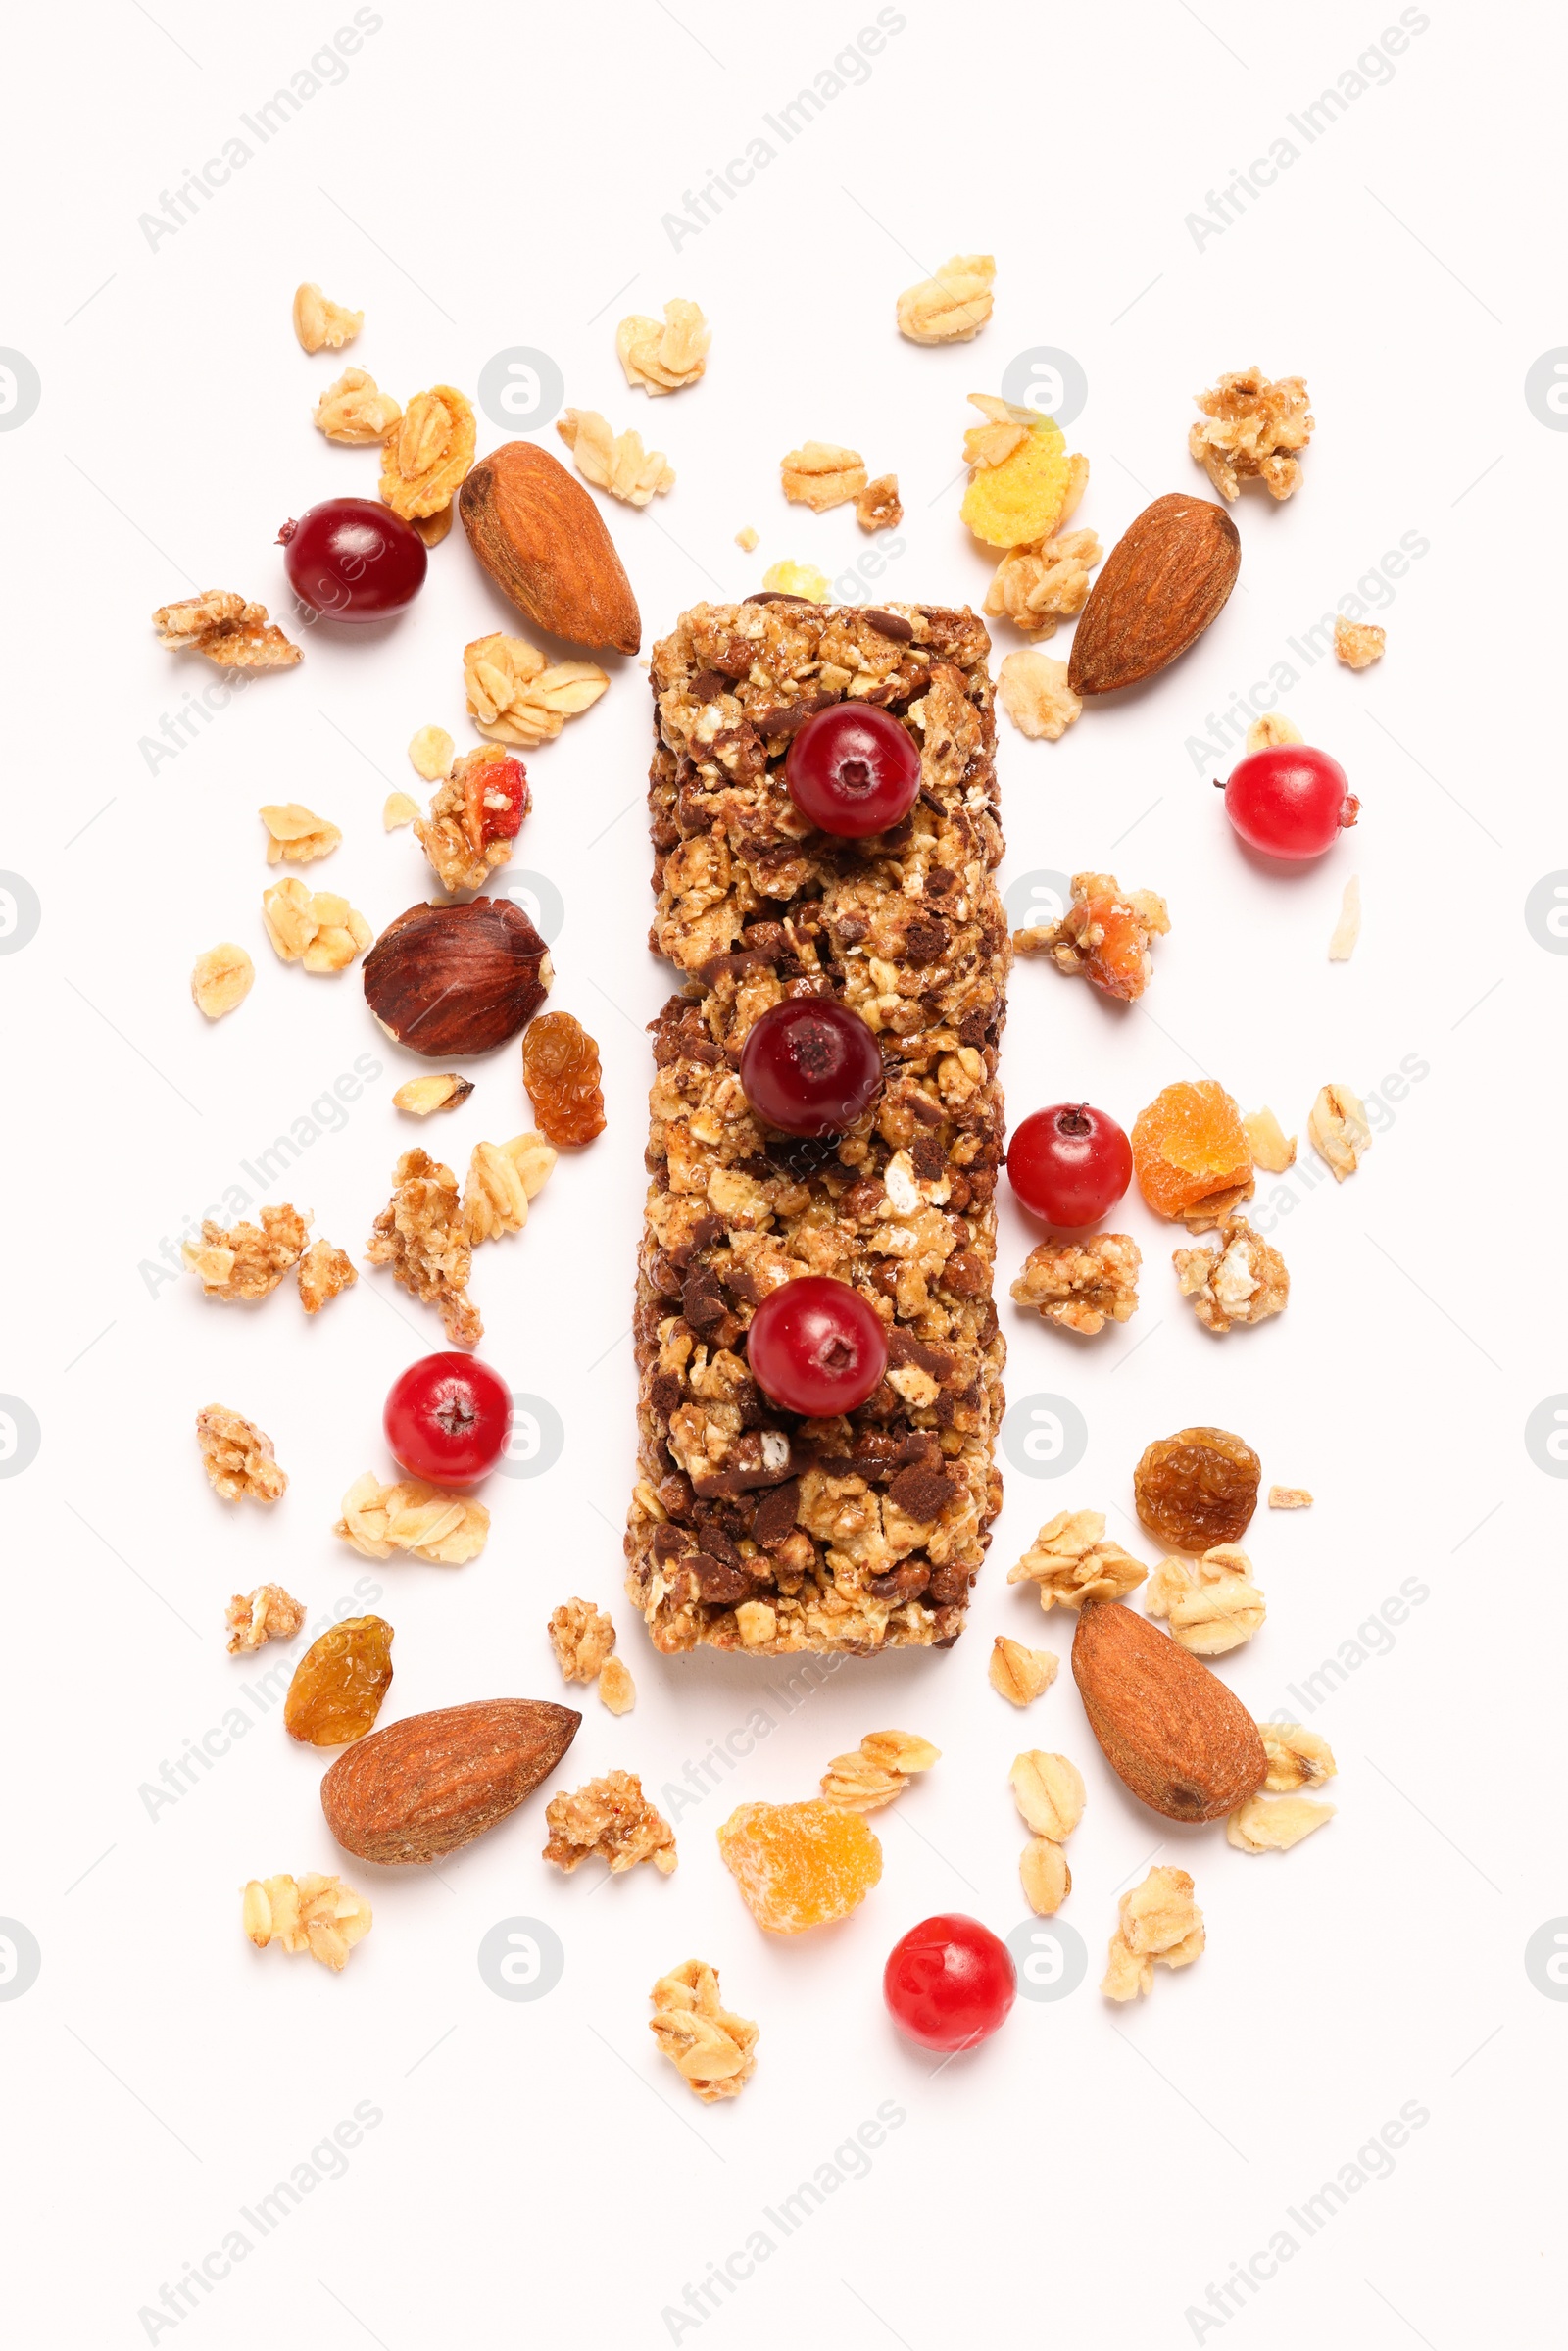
625,597,1010,1655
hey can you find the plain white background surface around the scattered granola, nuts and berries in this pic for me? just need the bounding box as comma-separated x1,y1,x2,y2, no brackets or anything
0,0,1568,2351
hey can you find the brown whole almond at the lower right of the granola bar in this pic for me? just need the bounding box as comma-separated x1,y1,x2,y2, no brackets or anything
1071,1601,1269,1820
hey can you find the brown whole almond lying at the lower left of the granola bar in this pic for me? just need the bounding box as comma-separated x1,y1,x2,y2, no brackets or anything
322,1697,583,1862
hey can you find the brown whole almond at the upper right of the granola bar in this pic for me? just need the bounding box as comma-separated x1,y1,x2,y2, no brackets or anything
1067,494,1242,694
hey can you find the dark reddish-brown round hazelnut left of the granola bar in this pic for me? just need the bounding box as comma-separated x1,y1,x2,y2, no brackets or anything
365,898,555,1060
